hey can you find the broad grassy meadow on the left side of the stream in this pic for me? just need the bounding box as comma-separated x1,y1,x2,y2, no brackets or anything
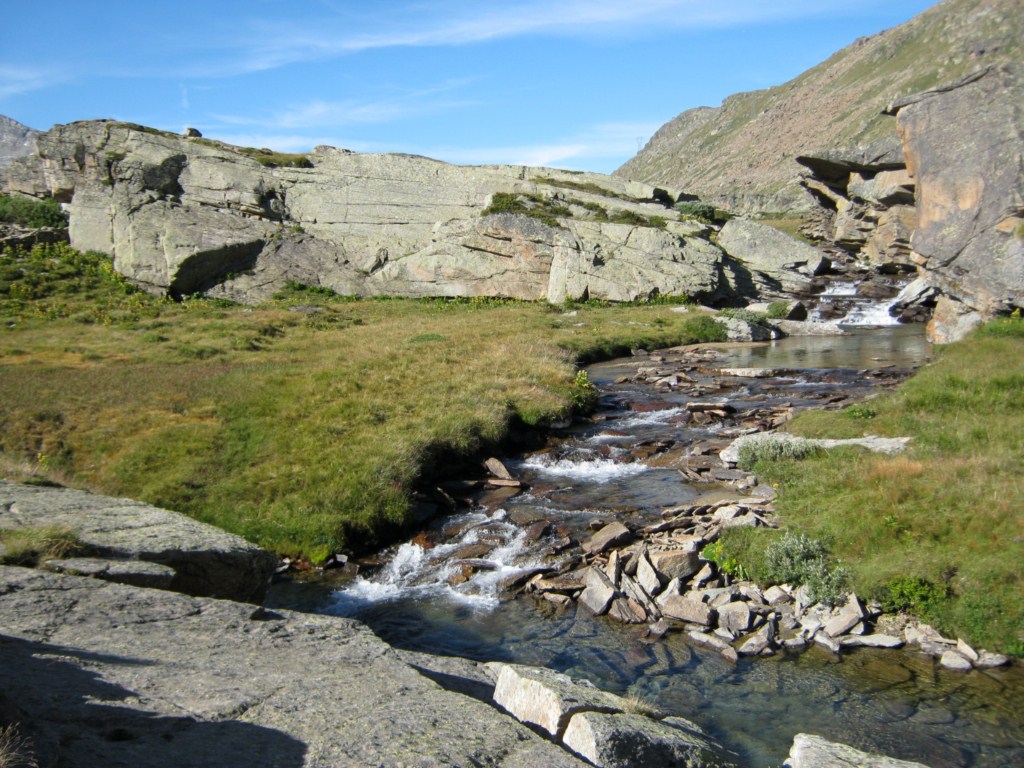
0,247,724,559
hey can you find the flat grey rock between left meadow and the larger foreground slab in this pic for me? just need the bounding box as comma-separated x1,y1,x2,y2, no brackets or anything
0,480,278,602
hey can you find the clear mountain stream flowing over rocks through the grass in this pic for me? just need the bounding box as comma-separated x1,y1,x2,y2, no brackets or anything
271,326,1024,768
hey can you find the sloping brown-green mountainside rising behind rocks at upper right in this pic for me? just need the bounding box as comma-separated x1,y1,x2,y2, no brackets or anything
613,0,1024,212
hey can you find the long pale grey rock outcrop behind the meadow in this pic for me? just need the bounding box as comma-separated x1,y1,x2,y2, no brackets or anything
0,121,823,303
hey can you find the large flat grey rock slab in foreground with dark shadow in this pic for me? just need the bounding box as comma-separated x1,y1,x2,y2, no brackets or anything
0,566,584,768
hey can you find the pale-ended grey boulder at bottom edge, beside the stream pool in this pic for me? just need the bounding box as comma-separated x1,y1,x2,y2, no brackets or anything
562,712,736,768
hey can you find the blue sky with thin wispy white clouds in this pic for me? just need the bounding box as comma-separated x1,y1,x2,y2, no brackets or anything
0,0,933,173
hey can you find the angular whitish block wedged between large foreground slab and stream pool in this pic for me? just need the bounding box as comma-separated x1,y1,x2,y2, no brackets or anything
485,662,625,738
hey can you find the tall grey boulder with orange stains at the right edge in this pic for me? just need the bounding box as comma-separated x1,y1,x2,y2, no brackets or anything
890,63,1024,341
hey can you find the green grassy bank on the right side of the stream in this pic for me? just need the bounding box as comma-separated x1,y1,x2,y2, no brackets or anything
725,317,1024,654
